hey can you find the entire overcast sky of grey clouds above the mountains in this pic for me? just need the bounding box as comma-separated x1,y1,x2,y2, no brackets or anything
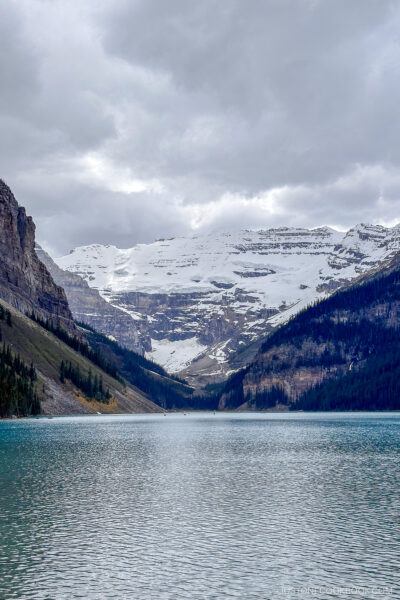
0,0,400,255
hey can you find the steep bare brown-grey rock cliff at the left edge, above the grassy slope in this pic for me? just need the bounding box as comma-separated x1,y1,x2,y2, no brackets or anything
0,180,74,330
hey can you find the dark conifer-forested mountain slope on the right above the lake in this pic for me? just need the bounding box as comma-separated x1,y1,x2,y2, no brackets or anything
219,257,400,409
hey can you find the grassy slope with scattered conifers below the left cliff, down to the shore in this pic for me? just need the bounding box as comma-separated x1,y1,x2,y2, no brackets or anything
0,302,161,416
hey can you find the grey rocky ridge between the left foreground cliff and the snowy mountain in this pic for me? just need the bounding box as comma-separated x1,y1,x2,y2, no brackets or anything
36,244,147,354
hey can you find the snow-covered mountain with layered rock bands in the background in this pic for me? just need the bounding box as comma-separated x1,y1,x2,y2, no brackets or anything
56,224,400,379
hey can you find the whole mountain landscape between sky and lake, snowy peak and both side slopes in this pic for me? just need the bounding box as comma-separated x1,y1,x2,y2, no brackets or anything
0,176,400,416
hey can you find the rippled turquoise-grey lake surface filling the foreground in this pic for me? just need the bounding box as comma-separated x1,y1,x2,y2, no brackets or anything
0,413,400,600
